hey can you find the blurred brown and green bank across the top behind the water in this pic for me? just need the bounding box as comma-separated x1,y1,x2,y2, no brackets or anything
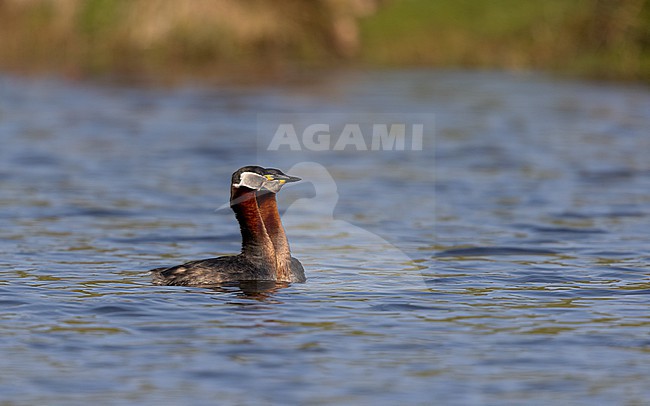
0,0,650,81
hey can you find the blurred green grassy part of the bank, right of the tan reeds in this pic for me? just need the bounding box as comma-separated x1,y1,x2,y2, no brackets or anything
361,0,650,81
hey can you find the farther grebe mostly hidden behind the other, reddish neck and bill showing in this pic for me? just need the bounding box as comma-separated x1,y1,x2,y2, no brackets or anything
256,168,307,282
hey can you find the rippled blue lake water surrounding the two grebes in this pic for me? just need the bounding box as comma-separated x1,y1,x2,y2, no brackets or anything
0,71,650,405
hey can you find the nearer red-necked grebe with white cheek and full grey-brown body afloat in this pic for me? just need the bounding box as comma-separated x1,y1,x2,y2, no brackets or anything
150,166,304,286
